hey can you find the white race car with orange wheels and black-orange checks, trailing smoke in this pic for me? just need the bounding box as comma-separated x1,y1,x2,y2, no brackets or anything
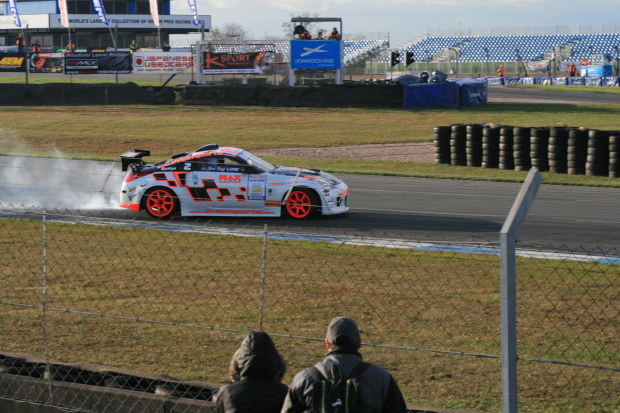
120,144,349,219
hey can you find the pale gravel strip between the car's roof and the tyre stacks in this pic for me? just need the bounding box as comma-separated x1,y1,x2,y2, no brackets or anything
255,142,435,163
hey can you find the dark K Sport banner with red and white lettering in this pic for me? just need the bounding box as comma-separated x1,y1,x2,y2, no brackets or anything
202,51,274,75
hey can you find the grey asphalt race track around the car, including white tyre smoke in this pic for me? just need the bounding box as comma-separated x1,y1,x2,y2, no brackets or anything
0,156,620,253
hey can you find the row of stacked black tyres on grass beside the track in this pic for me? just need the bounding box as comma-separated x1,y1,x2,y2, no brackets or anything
433,123,620,178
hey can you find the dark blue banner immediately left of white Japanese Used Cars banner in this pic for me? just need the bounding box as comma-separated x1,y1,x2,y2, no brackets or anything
65,52,131,75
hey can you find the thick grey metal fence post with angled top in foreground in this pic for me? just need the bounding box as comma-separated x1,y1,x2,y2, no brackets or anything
499,168,542,413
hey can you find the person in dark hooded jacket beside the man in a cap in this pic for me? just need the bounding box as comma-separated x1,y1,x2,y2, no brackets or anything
215,332,287,413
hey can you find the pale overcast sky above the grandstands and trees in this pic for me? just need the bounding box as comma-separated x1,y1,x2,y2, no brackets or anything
171,0,620,48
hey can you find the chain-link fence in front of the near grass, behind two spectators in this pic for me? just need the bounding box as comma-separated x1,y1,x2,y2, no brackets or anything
0,207,620,412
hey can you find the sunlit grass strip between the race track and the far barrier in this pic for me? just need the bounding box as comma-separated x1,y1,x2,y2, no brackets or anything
0,104,620,187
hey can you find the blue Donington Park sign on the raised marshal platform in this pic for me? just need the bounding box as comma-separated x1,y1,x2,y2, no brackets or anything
291,40,344,69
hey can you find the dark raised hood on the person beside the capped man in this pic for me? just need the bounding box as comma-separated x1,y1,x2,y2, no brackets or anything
236,332,286,380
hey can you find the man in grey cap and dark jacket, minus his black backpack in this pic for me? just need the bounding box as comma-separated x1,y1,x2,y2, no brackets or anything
281,317,407,413
